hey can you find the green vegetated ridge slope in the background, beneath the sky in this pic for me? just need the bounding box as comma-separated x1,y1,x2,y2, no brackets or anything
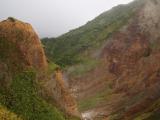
42,2,142,67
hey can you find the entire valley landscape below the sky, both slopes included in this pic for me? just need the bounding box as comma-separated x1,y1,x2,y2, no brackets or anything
0,0,160,120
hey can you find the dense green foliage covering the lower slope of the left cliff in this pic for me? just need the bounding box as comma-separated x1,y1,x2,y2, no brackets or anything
0,71,64,120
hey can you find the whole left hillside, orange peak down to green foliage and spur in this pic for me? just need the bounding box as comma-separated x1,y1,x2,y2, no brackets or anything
0,18,78,120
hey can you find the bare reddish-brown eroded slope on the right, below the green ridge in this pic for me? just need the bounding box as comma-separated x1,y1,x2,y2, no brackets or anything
69,0,160,120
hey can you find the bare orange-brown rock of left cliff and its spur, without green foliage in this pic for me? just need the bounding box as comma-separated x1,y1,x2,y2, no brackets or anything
0,18,80,119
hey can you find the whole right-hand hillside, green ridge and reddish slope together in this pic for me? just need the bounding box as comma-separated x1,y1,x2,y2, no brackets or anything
43,0,160,120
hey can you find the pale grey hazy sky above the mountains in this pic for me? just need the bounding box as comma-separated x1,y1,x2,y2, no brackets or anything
0,0,133,37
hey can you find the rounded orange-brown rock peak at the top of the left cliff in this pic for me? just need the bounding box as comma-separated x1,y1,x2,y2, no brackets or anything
0,18,47,70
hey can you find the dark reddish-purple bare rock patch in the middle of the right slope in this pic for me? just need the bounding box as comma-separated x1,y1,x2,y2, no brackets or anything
103,33,151,75
